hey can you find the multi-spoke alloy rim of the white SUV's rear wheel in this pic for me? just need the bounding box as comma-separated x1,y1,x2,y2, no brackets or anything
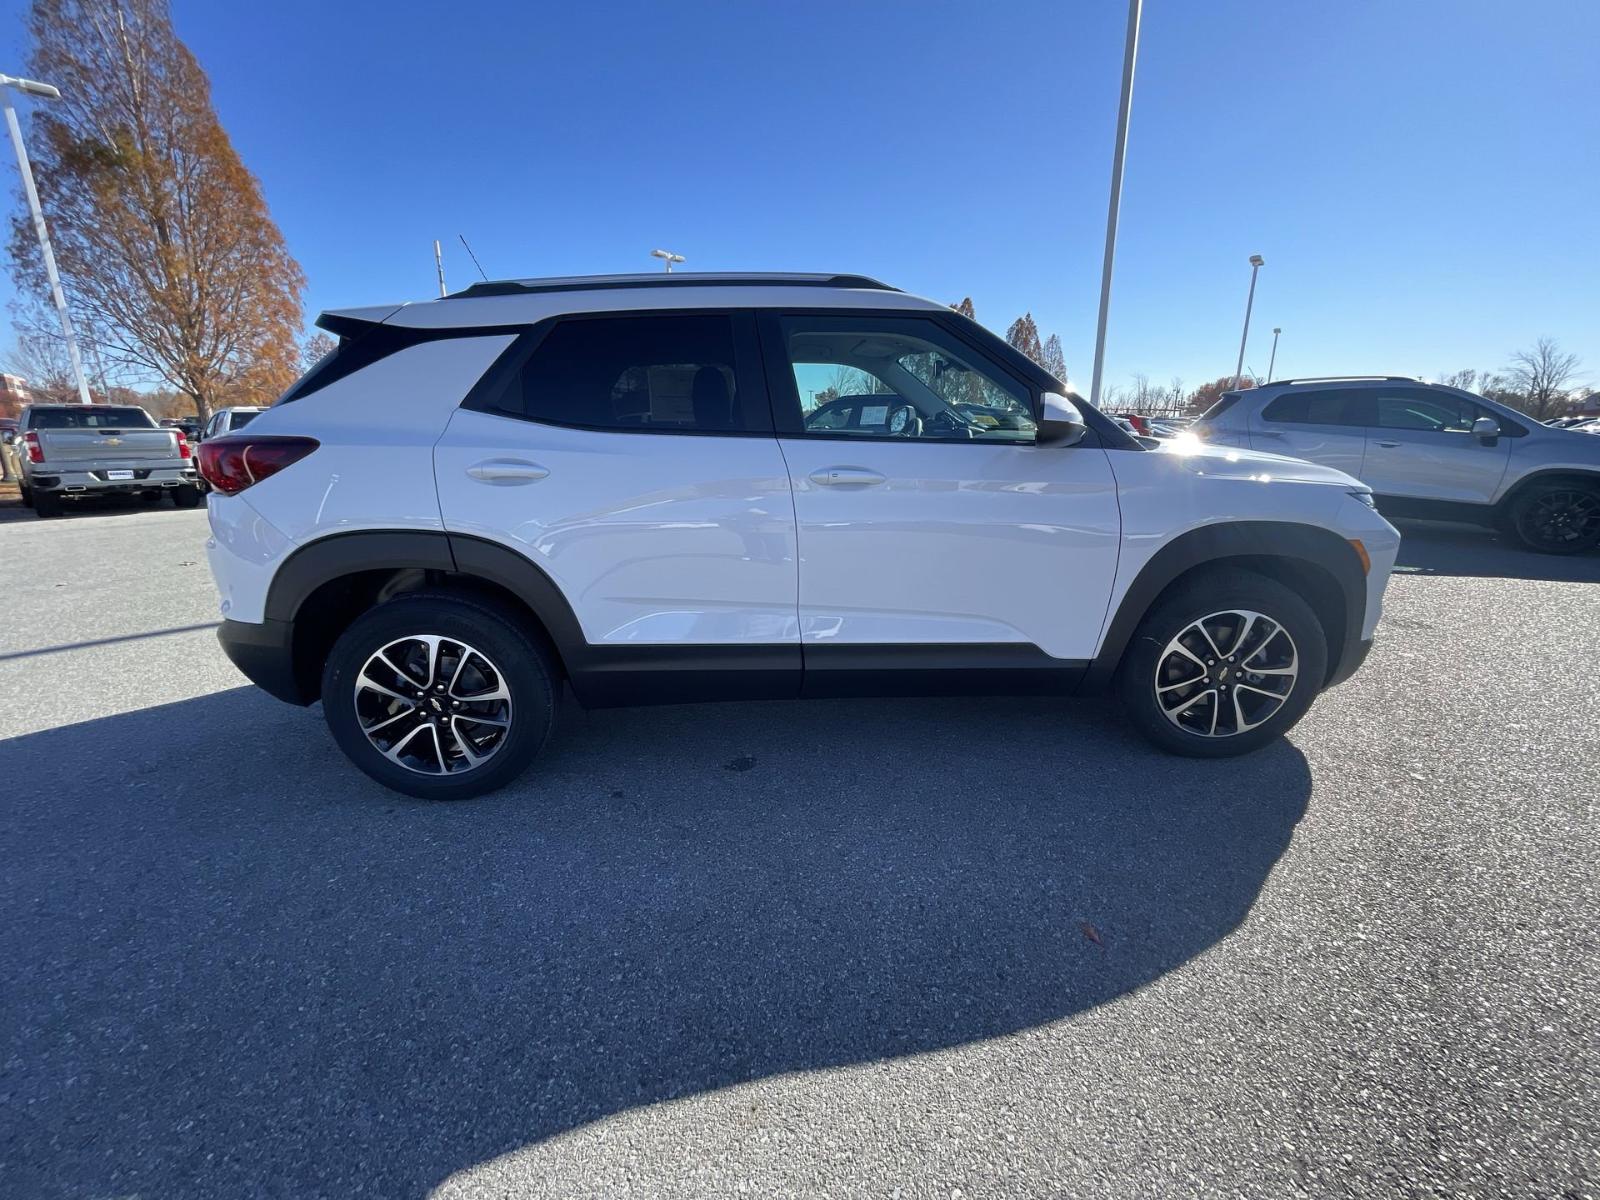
355,634,512,774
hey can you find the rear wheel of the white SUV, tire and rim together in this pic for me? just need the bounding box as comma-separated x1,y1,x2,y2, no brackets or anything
322,592,555,800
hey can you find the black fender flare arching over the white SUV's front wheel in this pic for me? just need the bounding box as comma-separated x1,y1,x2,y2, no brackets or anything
1083,522,1366,691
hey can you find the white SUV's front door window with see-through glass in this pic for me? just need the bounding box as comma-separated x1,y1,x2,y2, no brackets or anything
779,317,1035,442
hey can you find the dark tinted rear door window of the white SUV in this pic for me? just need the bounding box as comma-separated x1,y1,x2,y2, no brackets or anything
522,315,746,434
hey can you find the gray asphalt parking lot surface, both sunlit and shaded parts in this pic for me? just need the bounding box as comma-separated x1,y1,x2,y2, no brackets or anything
0,509,1600,1198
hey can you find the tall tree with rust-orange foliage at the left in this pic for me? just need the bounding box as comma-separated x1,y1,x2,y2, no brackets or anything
11,0,306,418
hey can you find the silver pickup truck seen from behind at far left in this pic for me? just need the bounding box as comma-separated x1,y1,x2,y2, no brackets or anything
6,405,200,517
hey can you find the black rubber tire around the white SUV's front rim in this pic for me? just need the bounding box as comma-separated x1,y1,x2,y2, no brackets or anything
1117,568,1328,758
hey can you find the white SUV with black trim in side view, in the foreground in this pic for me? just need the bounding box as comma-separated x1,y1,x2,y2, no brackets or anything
202,275,1400,798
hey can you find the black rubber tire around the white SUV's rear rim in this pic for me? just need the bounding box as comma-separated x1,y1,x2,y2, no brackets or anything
322,592,557,800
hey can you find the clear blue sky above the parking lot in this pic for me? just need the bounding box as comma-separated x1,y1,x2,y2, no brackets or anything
0,0,1600,390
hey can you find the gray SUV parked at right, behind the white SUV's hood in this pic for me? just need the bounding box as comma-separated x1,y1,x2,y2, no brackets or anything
1190,376,1600,554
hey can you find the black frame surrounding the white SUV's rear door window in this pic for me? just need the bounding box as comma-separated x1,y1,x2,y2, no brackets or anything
459,309,774,437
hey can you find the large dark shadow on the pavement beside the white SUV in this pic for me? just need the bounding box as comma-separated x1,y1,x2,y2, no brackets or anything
0,688,1310,1197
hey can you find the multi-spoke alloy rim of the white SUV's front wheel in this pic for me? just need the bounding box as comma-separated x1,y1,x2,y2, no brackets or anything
1155,608,1299,738
